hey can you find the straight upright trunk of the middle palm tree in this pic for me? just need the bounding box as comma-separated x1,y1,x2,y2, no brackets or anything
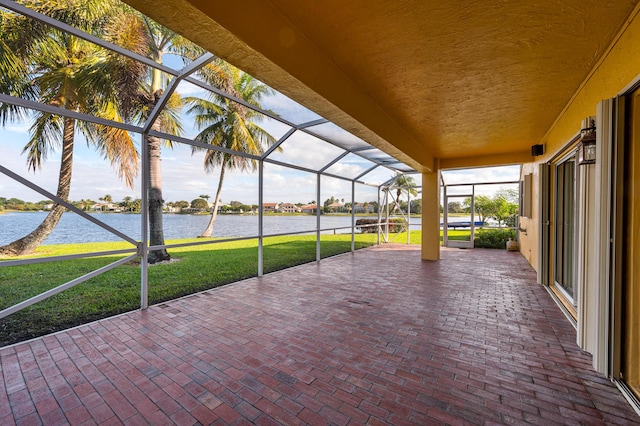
147,131,171,263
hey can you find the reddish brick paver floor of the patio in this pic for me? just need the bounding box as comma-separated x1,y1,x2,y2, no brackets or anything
0,245,640,425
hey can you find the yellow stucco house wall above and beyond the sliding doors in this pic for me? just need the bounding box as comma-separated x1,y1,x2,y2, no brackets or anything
520,4,640,270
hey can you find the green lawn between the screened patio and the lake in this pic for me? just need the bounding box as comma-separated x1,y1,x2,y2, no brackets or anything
0,234,378,345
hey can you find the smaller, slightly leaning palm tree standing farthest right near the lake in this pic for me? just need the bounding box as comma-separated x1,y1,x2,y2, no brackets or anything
185,60,276,237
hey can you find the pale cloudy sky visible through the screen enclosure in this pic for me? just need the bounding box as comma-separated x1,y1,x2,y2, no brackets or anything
0,55,519,208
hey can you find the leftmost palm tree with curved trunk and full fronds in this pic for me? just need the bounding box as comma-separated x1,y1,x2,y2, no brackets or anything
0,0,138,255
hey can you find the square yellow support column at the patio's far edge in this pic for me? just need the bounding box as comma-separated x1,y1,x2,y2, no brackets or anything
422,165,440,260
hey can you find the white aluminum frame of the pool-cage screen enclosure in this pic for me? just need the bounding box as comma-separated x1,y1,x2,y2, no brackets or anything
0,0,418,319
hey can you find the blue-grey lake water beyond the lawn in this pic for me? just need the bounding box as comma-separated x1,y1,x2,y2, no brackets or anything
0,212,420,245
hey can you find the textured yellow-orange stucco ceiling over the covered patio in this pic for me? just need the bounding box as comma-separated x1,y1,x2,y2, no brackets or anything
126,0,638,170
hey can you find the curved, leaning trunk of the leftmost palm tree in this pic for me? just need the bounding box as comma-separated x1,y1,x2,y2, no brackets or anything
0,118,75,256
